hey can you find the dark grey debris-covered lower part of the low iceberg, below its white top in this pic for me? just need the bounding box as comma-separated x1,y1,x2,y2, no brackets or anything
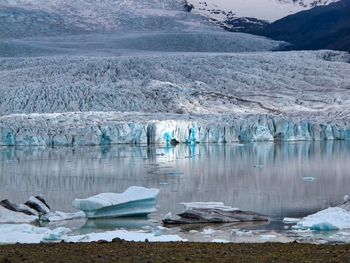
163,208,269,224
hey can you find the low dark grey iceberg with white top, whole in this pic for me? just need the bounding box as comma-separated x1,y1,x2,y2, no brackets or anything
163,202,269,224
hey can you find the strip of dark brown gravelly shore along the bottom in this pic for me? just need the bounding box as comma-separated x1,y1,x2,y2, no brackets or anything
0,241,350,263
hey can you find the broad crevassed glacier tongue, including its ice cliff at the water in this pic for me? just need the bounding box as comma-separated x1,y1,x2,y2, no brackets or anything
0,50,350,146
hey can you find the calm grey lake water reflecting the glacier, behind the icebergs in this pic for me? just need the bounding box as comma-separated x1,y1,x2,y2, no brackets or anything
0,141,350,220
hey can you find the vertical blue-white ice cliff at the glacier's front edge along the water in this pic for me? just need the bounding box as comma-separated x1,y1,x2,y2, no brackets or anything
0,112,350,146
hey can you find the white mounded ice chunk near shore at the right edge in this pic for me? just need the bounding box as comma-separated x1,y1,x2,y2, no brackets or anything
293,207,350,231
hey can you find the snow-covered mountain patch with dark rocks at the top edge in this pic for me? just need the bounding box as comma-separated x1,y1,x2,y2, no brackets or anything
188,0,339,31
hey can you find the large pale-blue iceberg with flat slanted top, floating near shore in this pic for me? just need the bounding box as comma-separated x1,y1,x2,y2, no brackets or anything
72,186,159,218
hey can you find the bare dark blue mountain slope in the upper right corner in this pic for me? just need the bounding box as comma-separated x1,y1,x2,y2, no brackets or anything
263,0,350,51
